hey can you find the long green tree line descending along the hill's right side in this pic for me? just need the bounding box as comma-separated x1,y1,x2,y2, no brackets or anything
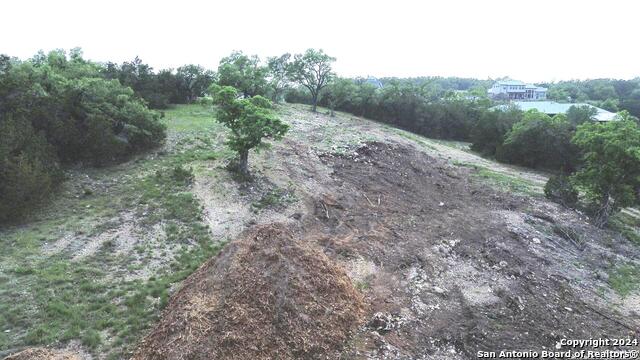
287,74,640,227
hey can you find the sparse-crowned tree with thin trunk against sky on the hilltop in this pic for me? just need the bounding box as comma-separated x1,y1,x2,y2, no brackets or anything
291,49,336,112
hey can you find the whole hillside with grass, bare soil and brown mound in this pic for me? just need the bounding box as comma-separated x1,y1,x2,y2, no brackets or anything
0,105,640,359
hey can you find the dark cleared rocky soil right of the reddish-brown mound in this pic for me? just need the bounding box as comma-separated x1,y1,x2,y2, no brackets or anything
306,143,639,359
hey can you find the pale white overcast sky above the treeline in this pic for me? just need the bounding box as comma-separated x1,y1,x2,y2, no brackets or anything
0,0,640,82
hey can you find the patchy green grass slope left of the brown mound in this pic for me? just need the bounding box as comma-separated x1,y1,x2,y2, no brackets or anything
0,105,228,359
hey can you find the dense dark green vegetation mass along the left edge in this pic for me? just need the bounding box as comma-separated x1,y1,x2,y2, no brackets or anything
0,50,165,220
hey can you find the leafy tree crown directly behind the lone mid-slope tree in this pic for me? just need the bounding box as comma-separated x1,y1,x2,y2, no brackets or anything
218,51,268,97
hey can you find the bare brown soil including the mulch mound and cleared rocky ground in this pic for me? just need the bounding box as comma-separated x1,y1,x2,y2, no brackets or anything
136,134,640,359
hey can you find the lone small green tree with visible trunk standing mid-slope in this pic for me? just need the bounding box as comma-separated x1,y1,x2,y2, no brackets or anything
210,85,289,176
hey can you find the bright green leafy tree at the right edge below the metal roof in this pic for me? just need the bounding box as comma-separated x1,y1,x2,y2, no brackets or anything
572,111,640,227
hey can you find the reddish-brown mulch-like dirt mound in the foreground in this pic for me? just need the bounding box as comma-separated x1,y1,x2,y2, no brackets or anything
133,225,364,359
